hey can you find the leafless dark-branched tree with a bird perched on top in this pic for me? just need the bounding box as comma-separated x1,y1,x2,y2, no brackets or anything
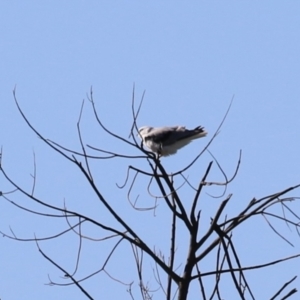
1,90,300,300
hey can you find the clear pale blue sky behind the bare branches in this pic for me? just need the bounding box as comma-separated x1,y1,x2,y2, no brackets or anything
0,1,300,300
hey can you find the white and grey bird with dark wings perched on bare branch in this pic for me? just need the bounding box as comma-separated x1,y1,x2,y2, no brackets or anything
138,126,207,156
